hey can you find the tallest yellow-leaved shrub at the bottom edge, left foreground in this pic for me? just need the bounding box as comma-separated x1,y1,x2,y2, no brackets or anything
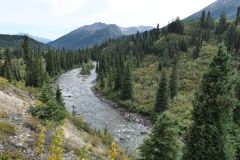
48,128,64,160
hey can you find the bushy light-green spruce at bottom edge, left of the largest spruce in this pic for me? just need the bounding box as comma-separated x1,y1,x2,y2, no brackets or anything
140,112,182,160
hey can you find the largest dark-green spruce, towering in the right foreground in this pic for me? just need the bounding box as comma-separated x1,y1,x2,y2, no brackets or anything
185,45,236,160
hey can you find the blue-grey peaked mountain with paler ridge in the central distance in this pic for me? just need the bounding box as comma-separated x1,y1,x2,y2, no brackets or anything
48,22,152,49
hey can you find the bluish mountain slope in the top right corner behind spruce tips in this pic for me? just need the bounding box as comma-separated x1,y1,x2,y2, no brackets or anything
185,0,240,21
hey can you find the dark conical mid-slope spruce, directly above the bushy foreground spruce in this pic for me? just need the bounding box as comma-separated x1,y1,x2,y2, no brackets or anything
155,71,169,113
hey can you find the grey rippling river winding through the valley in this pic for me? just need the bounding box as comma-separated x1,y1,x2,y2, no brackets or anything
56,69,148,153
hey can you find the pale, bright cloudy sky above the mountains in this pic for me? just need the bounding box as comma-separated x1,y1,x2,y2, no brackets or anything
0,0,216,40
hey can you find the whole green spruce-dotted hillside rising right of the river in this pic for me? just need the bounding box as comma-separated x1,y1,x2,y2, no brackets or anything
96,8,240,160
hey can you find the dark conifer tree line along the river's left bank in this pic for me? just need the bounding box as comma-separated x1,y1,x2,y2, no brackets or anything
0,36,91,87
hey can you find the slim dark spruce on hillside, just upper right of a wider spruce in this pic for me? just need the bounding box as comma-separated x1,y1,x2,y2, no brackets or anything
169,63,178,99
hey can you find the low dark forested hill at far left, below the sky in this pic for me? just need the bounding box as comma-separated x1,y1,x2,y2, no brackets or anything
0,34,52,50
